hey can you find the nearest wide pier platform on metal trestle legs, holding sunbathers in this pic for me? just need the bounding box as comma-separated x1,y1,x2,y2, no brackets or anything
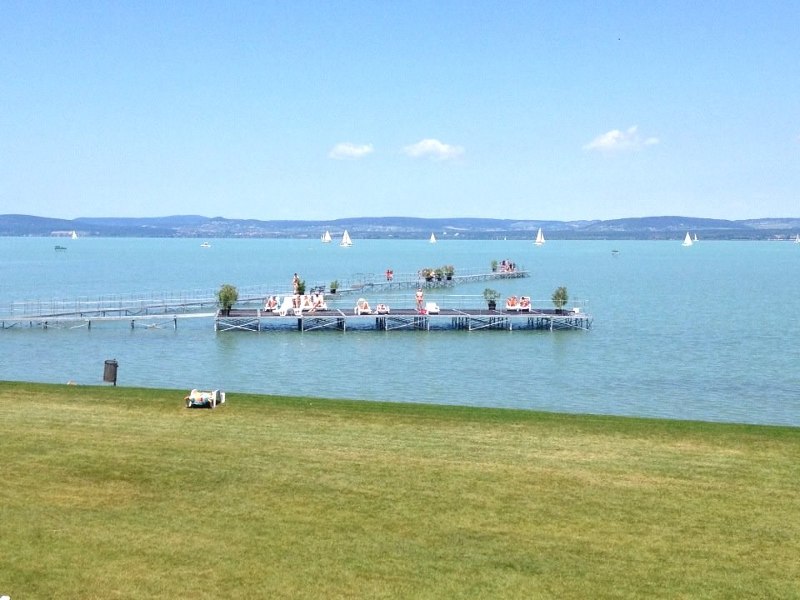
214,308,593,332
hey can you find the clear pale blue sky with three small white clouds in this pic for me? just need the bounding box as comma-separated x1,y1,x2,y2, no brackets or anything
0,0,800,220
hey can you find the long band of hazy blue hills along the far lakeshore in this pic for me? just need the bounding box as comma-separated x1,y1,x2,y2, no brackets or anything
0,214,800,241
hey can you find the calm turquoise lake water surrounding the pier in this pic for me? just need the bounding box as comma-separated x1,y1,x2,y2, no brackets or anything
0,237,800,425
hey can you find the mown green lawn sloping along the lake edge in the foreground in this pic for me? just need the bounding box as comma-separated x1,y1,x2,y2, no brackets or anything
0,383,800,600
